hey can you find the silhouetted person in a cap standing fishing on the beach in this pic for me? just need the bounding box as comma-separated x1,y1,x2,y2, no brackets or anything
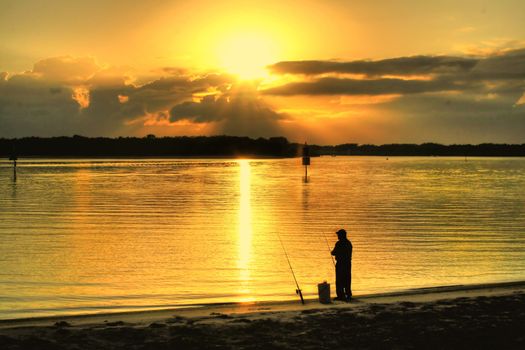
332,229,352,301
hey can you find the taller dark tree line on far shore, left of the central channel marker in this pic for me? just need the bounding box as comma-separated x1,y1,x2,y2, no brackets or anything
0,135,297,157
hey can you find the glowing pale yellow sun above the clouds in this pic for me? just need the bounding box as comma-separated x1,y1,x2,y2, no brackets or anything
217,32,278,80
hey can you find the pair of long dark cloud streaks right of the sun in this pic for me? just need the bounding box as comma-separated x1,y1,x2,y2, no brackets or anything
264,49,525,96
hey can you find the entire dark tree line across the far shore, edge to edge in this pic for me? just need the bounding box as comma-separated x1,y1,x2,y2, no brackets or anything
0,135,525,158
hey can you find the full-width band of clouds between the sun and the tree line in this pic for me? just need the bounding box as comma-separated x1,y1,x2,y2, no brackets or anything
0,49,525,143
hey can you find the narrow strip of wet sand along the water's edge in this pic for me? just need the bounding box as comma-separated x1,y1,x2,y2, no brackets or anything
0,280,525,329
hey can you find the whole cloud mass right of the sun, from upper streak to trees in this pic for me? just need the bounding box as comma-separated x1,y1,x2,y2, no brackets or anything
262,48,525,143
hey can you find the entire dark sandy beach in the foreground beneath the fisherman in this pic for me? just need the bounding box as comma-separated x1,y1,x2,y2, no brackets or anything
0,281,525,350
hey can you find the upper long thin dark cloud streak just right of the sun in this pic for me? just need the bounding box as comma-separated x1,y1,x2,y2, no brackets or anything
268,56,479,77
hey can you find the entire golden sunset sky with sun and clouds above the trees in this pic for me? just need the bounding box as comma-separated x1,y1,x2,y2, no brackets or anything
0,0,525,144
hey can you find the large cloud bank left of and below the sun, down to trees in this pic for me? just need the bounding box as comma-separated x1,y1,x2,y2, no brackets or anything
0,56,282,137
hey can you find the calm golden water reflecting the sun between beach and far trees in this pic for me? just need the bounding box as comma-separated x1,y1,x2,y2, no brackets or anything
0,157,525,319
